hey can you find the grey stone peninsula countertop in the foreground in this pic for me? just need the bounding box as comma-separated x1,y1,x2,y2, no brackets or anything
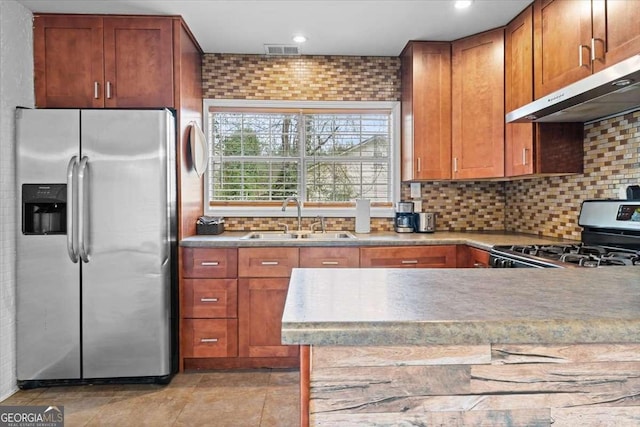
282,267,640,345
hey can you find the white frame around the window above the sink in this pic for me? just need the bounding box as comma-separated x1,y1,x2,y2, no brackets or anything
203,99,400,218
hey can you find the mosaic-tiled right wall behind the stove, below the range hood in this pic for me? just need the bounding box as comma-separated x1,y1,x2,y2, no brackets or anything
505,111,640,240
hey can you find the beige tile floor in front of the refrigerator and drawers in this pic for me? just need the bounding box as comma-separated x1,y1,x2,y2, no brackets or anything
0,369,300,427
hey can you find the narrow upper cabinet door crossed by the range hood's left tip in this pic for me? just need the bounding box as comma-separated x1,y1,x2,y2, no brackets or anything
505,6,534,176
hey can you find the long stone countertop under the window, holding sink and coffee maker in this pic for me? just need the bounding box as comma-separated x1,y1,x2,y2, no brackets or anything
180,231,567,250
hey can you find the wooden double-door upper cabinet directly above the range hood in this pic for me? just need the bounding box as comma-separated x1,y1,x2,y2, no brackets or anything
533,0,640,99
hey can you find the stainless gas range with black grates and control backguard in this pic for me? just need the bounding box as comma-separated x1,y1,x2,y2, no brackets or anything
489,200,640,273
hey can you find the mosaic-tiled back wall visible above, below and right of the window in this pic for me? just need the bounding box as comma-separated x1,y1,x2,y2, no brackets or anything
202,54,504,231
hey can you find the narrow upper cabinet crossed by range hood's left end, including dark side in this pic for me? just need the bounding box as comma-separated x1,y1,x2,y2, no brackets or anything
505,6,584,177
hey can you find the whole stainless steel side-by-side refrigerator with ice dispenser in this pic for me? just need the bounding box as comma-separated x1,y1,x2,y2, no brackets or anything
16,108,177,388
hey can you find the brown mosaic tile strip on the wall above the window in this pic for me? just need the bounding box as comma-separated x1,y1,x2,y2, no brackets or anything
202,53,400,101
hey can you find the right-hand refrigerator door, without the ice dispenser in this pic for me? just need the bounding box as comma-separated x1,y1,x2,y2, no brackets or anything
79,110,175,379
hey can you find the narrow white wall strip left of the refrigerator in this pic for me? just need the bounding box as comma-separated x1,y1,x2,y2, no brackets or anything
0,0,34,401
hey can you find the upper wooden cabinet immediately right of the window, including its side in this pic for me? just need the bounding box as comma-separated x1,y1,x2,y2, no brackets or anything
400,42,451,181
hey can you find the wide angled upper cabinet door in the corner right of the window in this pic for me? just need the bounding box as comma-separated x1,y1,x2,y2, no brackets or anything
452,28,504,179
